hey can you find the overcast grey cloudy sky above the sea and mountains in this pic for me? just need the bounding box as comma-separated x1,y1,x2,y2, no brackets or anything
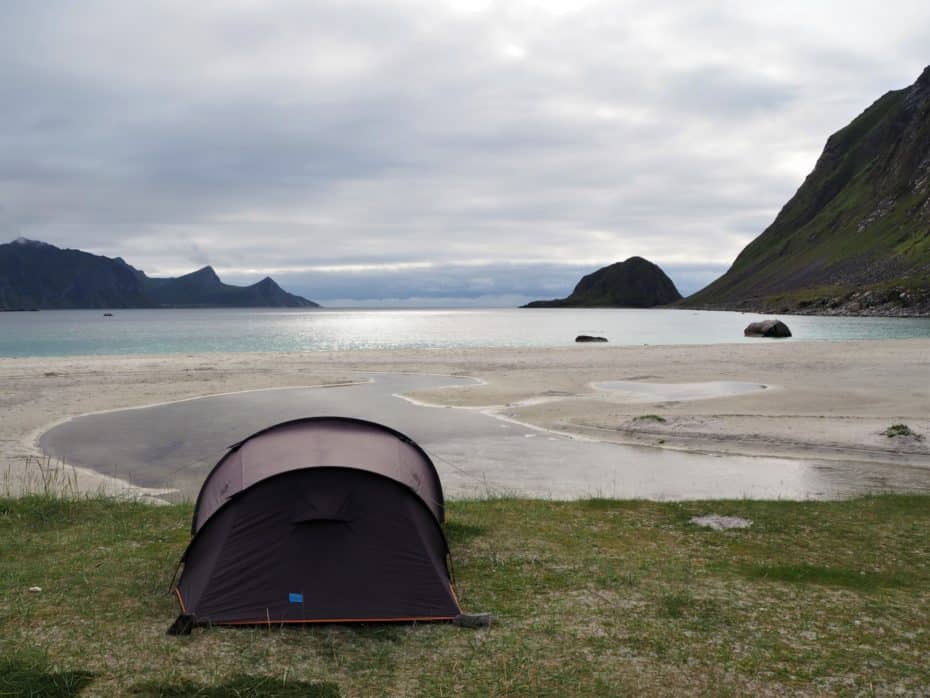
0,0,930,306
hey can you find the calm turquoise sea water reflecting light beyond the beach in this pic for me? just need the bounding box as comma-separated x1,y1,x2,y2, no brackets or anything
0,308,930,357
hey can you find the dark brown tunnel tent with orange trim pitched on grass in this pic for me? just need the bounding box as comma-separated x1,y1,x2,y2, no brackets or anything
169,417,461,634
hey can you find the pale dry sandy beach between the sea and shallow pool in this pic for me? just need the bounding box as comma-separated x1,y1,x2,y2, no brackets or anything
0,339,930,495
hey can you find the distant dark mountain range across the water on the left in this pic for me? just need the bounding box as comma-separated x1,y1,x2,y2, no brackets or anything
0,238,319,310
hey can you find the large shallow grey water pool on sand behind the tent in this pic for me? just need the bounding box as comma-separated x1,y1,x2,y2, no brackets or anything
40,374,930,500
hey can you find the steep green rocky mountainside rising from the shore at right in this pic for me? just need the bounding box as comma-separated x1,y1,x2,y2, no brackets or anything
682,66,930,315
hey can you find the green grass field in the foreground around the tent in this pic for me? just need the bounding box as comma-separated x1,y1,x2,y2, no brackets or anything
0,495,930,696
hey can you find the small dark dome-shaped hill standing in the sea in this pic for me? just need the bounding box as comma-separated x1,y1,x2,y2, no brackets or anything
523,257,681,308
